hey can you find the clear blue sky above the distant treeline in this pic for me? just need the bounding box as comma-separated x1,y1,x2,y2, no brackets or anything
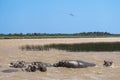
0,0,120,33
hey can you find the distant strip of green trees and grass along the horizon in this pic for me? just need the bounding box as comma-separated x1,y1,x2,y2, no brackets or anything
0,32,120,39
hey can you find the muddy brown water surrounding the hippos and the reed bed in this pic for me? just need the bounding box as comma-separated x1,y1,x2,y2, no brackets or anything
0,38,120,80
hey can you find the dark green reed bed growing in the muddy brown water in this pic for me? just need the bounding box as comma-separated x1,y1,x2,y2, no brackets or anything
20,42,120,52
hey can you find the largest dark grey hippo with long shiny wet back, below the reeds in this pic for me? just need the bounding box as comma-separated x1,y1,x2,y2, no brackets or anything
53,60,96,68
